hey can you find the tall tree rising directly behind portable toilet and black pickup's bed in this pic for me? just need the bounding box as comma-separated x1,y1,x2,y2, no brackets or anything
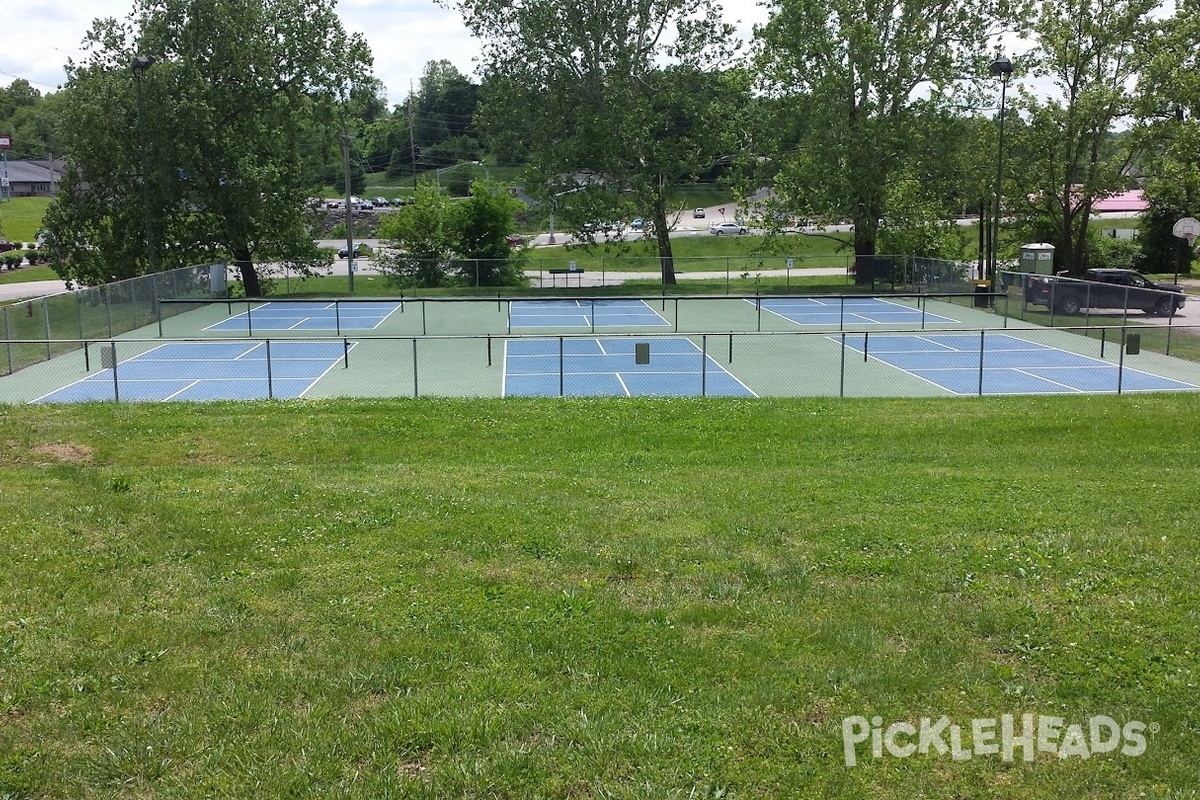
1009,0,1159,275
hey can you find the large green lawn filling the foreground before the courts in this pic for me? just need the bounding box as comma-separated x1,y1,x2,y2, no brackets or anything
0,396,1200,799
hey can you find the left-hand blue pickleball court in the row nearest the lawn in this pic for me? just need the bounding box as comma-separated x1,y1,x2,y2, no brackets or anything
34,341,353,403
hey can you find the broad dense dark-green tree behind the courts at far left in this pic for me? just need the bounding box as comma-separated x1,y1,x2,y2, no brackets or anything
46,0,370,295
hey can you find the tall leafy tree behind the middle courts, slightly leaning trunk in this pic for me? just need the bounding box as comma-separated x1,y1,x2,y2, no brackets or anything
456,0,746,284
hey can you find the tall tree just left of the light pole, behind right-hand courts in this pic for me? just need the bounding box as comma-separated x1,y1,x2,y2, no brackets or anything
760,0,1021,281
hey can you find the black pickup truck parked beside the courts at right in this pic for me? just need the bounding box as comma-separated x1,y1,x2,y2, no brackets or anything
1025,270,1187,317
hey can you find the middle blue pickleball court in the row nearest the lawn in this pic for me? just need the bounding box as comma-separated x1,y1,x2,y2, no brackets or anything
504,337,755,397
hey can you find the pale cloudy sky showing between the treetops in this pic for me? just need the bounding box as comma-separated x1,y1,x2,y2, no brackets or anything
0,0,766,104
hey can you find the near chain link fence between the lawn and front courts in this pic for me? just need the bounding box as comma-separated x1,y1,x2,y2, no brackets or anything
9,326,1200,402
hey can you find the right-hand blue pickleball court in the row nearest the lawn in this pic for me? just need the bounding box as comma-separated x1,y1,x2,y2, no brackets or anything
830,333,1200,395
